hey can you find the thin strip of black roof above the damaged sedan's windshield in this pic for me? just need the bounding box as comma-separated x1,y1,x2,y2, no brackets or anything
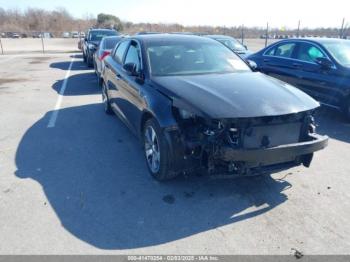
130,34,214,44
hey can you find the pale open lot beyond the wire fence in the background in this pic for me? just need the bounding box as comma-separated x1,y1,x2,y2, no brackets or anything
0,38,275,55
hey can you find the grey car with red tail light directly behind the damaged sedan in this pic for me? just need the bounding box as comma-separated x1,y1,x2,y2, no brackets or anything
94,36,123,85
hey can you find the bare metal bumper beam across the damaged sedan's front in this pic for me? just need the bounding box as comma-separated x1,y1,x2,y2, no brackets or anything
220,134,328,166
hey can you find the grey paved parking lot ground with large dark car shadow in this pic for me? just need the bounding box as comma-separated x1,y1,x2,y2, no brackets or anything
0,54,350,254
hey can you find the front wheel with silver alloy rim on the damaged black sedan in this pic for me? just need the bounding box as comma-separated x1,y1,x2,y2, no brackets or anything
142,118,177,181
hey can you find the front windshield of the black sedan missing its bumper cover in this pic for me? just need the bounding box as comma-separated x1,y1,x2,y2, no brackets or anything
147,42,250,76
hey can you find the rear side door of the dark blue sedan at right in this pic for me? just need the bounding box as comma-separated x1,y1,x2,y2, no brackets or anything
261,41,298,85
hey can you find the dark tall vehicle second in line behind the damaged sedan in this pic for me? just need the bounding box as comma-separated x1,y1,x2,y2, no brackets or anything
82,29,119,66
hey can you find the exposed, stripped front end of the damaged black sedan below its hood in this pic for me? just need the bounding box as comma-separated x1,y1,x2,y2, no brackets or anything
166,111,328,176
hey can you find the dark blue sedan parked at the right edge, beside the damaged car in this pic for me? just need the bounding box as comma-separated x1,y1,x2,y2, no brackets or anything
248,38,350,120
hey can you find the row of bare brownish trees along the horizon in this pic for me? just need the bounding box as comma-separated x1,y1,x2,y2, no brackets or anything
0,7,350,38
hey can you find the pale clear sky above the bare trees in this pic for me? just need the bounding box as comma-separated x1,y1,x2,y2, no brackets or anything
0,0,350,28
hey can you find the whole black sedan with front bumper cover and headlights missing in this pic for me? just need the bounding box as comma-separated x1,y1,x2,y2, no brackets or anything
102,34,328,180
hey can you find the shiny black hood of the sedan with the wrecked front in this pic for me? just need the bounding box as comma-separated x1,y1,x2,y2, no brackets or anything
152,72,319,119
